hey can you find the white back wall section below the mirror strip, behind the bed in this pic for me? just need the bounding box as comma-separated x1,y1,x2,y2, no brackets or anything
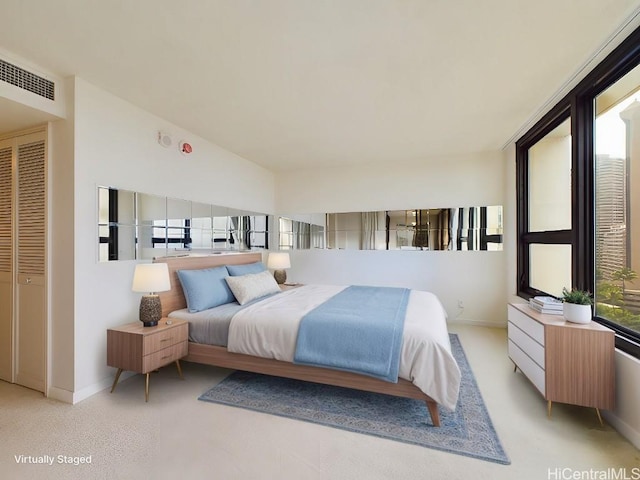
287,250,506,326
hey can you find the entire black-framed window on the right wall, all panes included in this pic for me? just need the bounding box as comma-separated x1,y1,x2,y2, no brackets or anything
516,25,640,357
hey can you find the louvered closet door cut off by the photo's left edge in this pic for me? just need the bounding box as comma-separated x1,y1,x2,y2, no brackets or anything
0,140,14,382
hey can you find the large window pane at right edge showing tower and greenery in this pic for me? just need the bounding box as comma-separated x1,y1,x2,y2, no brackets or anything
594,67,640,332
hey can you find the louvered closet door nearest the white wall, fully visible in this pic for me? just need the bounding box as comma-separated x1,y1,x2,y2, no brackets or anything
15,137,46,392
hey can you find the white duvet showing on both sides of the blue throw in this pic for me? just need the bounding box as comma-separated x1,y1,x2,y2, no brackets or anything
227,285,460,410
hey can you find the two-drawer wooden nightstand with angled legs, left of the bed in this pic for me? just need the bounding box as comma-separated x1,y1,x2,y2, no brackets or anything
107,318,189,402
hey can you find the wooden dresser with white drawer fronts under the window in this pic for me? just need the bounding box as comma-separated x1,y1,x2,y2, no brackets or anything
507,304,615,421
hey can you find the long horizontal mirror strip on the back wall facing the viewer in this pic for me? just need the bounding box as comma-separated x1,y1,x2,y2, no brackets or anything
279,205,503,251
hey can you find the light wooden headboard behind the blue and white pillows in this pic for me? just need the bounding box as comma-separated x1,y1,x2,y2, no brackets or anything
153,253,262,317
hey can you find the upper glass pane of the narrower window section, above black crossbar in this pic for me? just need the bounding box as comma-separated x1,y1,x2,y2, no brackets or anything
528,119,571,232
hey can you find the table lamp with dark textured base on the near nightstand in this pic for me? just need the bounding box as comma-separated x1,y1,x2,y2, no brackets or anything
131,263,171,327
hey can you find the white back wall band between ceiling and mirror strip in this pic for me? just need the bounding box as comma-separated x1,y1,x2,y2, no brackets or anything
276,151,504,213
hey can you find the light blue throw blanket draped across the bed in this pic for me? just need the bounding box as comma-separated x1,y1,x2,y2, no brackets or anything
293,286,410,383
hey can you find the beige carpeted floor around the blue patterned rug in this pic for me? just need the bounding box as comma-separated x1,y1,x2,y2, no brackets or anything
0,324,640,480
